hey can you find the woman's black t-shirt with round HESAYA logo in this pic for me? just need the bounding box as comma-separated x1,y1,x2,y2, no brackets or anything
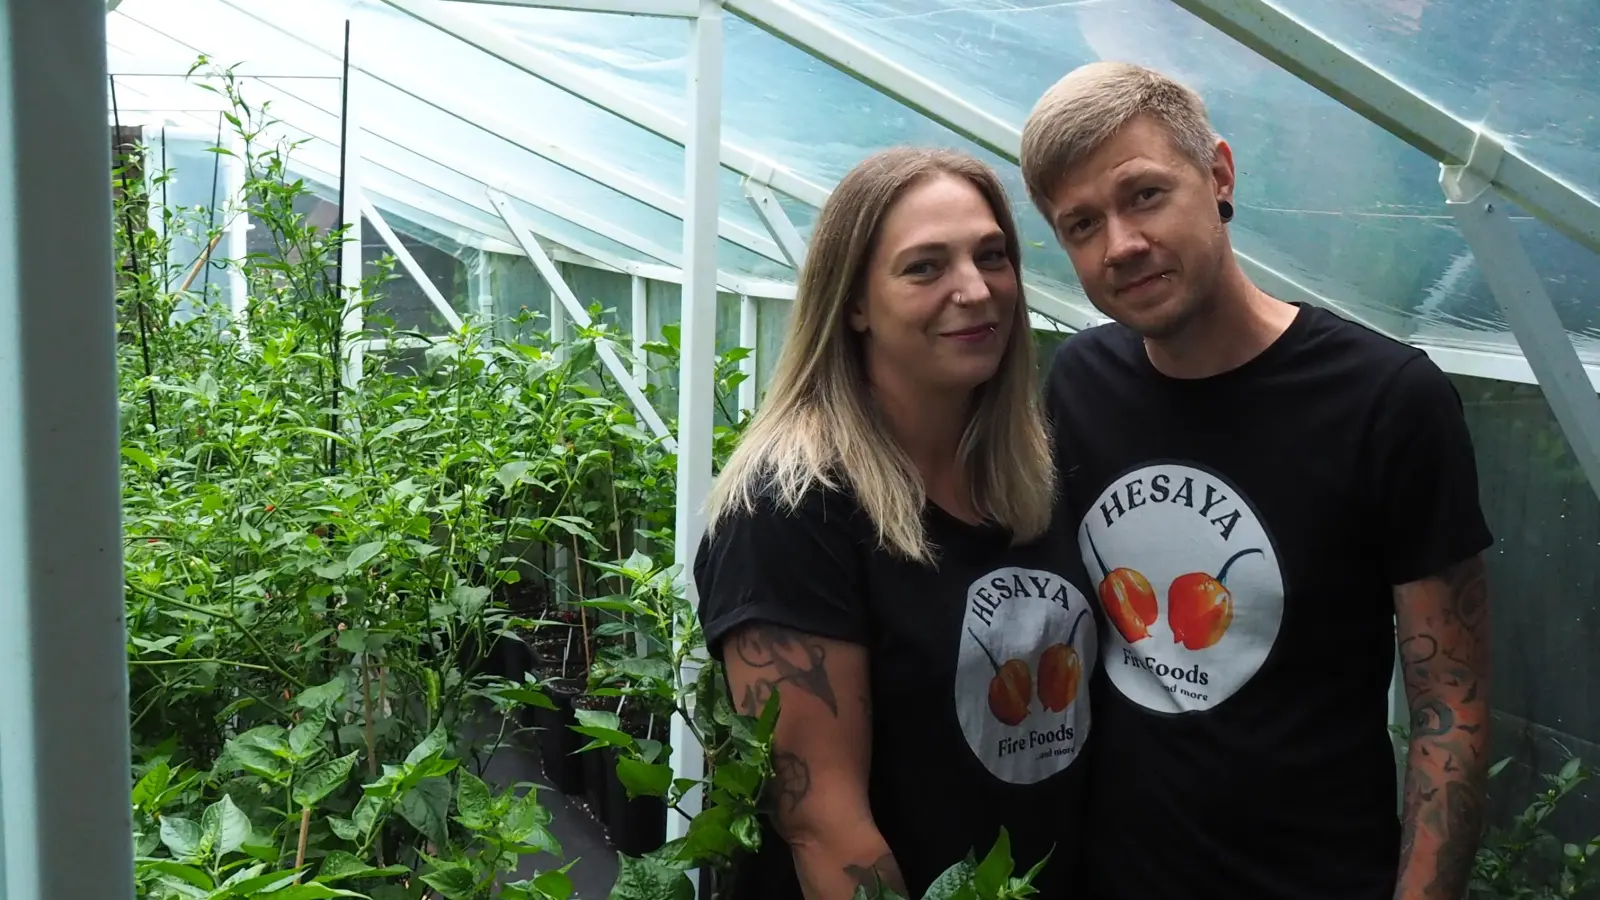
694,488,1098,900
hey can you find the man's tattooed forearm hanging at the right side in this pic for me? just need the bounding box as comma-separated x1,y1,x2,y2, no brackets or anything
1395,556,1490,900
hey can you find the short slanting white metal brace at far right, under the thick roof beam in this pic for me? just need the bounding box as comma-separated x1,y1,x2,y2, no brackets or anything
1438,133,1600,495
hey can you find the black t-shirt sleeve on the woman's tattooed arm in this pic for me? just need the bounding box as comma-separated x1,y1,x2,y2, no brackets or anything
694,490,867,661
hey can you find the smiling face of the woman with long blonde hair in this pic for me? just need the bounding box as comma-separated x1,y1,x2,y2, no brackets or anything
850,173,1018,394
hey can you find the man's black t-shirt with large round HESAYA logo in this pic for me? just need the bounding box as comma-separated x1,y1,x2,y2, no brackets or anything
1046,306,1491,900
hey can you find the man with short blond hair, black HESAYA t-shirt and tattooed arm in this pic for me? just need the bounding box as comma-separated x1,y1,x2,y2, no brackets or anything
1021,64,1493,900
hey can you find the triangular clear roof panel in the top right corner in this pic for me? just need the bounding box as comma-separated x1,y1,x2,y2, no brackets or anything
1274,0,1600,197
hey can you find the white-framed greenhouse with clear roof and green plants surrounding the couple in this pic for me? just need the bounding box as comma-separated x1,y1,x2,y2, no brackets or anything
0,0,1600,900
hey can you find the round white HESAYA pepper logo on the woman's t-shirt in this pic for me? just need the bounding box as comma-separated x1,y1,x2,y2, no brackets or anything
955,569,1096,785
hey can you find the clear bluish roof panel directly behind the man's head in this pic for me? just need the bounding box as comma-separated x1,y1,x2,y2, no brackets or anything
771,0,1600,346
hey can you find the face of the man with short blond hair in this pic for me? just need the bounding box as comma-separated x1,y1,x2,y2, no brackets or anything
1050,117,1234,340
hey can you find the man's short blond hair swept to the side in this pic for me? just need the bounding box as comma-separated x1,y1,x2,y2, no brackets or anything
1019,62,1218,219
